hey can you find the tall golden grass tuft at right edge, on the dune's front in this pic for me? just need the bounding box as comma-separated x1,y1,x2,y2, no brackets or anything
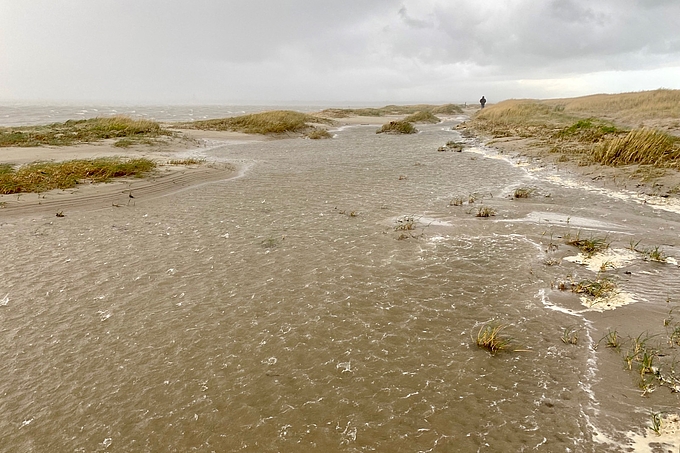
591,128,680,167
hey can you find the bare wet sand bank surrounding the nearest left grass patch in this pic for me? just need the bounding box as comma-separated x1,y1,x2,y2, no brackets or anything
0,131,256,222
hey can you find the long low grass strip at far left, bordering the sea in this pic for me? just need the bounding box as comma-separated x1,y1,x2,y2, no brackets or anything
0,116,173,147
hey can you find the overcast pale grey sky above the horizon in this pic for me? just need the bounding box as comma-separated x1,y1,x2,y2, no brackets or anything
0,0,680,104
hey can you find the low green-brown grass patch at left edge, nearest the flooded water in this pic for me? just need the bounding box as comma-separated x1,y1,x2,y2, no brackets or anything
0,157,156,194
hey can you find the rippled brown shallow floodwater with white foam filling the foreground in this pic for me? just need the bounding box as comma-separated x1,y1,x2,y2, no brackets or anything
0,113,680,452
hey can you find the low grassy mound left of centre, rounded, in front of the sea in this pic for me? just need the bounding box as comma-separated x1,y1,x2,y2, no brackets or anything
176,110,333,135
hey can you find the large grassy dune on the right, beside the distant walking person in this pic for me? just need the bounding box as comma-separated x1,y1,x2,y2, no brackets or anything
471,89,680,168
